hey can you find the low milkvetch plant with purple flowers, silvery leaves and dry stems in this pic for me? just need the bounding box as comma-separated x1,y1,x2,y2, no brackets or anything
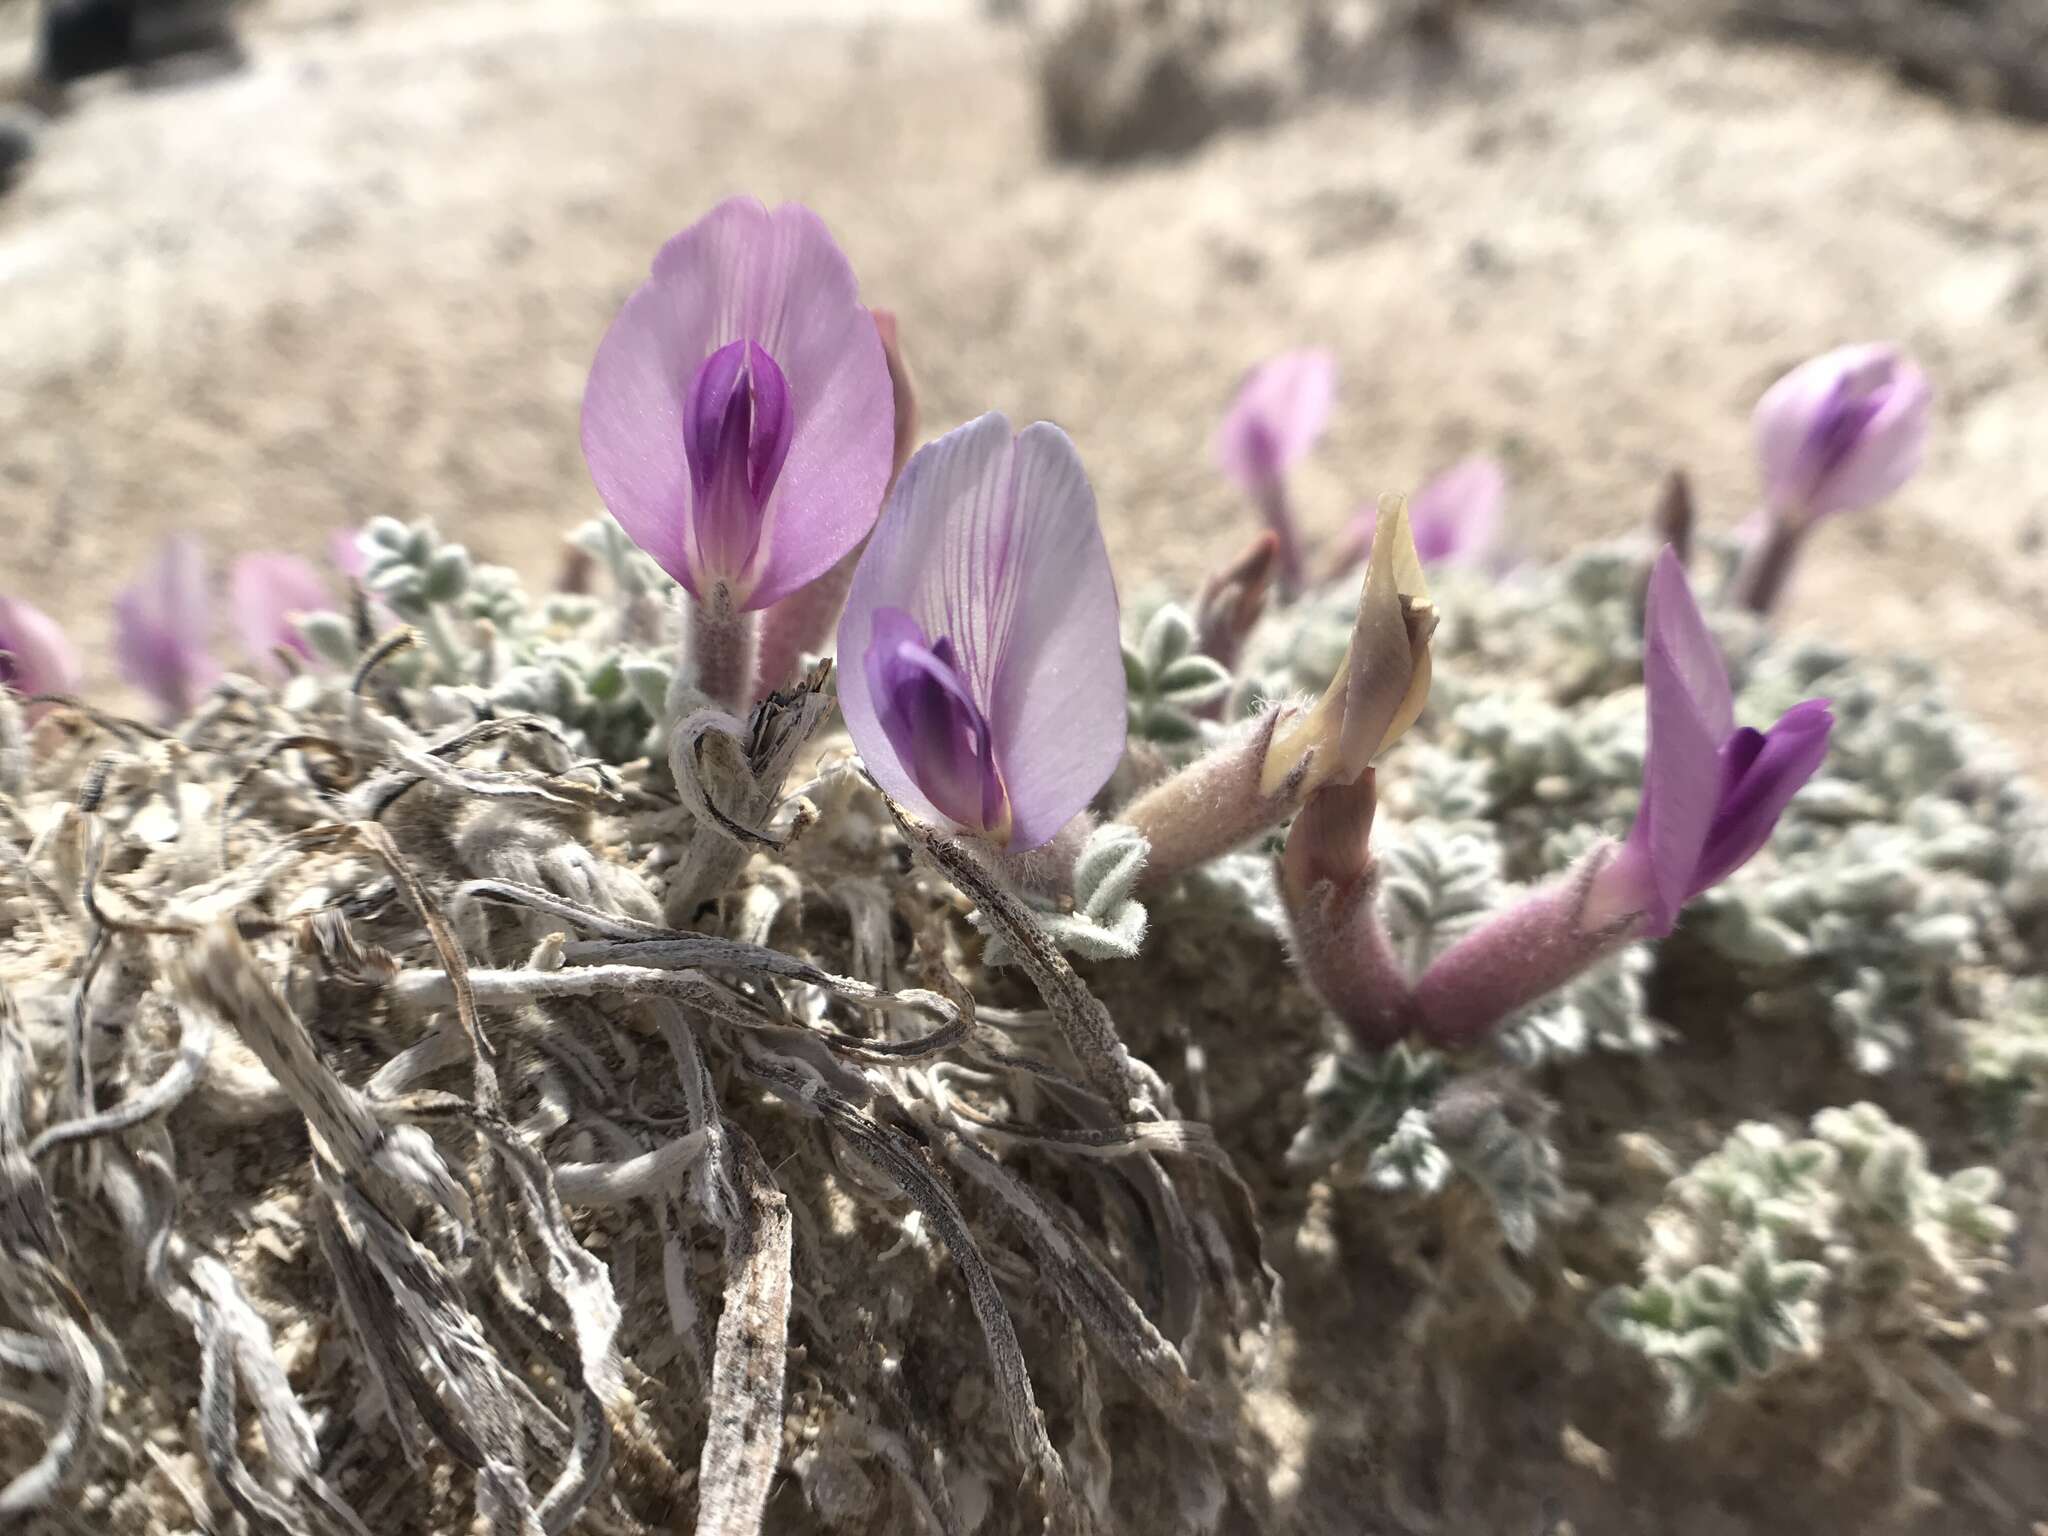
0,180,2048,1536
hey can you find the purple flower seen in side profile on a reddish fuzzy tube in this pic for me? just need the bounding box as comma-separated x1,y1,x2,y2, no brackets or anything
1589,549,1835,936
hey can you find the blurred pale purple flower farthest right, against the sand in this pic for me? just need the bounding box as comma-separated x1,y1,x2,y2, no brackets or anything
1755,344,1933,520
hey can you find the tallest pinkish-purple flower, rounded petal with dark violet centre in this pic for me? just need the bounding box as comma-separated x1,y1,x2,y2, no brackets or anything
584,199,895,610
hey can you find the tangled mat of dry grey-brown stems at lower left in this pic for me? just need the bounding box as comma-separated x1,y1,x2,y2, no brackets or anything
0,651,1272,1536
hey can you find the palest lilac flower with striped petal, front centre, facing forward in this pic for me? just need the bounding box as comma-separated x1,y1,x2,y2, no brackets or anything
838,412,1124,852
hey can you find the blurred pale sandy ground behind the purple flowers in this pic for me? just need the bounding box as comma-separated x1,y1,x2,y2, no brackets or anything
0,0,2048,770
